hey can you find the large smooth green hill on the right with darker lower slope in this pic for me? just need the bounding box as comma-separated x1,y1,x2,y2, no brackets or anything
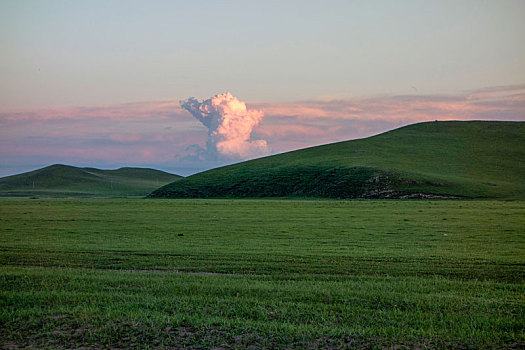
150,121,525,199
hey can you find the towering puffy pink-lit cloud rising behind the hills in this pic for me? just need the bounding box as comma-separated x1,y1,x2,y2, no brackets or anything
181,92,269,159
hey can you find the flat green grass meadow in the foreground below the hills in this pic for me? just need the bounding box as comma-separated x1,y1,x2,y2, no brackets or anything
0,198,525,349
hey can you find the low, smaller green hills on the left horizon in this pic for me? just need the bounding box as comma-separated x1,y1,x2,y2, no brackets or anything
0,164,181,197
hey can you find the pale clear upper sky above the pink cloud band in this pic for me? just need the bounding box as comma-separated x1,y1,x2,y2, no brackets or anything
0,0,525,109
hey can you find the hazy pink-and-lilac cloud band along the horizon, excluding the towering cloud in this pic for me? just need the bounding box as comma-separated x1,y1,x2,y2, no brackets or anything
0,84,525,176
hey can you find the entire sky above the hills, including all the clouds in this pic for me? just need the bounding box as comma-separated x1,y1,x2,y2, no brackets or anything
0,0,525,176
